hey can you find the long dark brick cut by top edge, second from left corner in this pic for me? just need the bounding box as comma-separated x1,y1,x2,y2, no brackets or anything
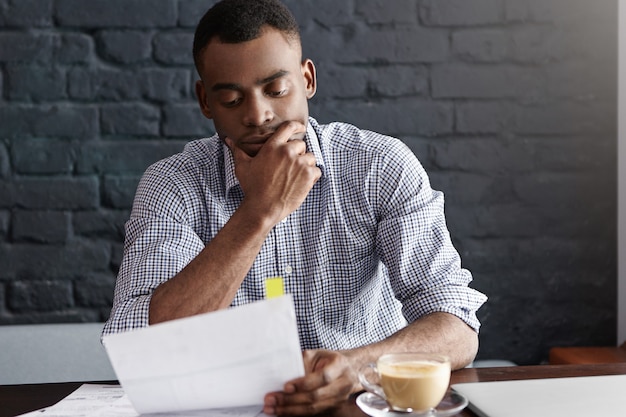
55,0,178,29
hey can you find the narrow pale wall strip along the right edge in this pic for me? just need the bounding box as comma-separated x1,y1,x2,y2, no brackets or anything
617,0,626,343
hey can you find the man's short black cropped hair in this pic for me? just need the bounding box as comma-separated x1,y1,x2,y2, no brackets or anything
193,0,300,70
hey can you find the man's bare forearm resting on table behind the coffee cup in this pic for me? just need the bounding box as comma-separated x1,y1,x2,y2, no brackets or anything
345,312,478,369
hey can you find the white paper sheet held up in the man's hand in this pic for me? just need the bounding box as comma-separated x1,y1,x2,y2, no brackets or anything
103,295,304,414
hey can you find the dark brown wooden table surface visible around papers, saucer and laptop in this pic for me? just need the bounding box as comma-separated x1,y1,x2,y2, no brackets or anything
0,363,626,417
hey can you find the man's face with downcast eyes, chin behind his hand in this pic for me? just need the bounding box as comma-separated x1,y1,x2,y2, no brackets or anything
196,28,316,156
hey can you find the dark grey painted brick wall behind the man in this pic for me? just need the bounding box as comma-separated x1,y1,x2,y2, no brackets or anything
0,0,617,364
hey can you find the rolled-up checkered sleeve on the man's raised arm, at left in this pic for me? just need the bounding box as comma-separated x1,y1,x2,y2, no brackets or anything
103,162,204,335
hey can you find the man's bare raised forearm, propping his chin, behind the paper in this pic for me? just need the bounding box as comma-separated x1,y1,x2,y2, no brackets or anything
149,200,273,324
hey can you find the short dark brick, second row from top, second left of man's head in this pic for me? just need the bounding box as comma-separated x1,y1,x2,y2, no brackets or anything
97,30,152,64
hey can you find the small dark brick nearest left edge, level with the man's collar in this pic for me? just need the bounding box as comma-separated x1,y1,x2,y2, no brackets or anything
11,139,76,174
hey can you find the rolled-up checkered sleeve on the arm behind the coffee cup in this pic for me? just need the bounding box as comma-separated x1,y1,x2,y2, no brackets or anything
373,140,487,332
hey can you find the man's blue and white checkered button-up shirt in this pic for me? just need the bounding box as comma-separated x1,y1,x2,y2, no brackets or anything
104,118,486,349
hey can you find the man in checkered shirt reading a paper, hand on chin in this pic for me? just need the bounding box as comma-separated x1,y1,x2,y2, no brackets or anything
104,0,485,415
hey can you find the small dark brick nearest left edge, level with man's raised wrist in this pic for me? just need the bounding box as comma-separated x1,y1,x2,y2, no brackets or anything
12,210,70,243
